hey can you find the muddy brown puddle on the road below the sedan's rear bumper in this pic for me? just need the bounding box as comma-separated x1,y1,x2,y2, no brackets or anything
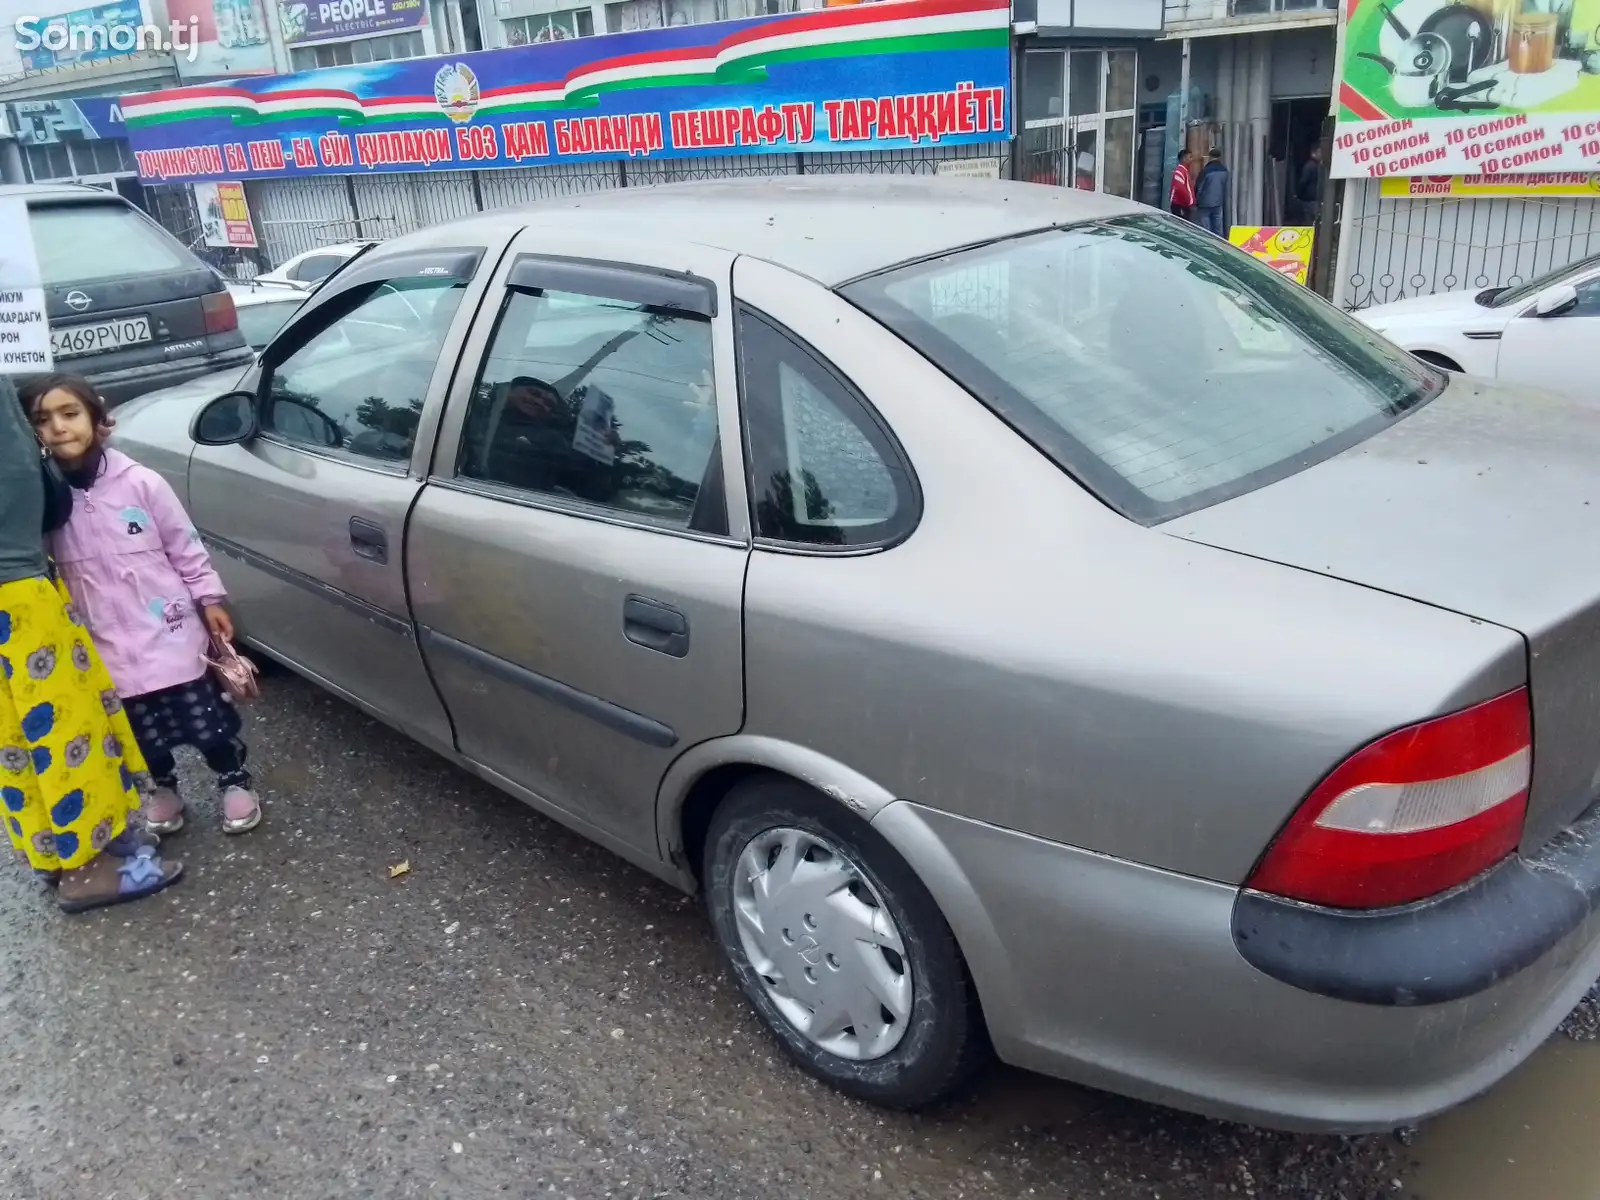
1408,1034,1600,1200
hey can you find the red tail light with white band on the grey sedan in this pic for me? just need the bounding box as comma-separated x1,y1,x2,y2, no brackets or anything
1245,688,1533,909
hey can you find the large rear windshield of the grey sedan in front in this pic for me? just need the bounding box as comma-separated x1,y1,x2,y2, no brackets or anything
843,216,1446,523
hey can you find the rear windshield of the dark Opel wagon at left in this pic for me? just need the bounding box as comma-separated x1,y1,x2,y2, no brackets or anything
29,202,200,288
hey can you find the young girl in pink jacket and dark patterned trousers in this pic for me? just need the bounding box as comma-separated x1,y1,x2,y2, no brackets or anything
24,374,261,834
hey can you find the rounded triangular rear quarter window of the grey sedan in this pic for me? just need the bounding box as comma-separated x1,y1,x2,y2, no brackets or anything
738,309,920,549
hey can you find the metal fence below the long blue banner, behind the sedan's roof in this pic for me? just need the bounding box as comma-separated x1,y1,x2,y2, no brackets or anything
137,146,1005,278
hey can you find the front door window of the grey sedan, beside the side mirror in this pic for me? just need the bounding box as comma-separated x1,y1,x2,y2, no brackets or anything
261,278,466,462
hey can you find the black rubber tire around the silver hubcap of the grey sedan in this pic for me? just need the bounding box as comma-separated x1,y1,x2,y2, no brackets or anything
702,776,990,1110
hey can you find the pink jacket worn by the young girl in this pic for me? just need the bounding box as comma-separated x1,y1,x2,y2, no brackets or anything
50,448,227,696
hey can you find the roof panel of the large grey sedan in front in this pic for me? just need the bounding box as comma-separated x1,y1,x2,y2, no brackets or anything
379,174,1154,286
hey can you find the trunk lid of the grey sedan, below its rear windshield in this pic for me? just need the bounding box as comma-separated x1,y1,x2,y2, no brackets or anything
1162,378,1600,850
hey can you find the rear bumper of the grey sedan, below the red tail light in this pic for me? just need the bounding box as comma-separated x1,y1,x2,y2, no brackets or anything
874,802,1600,1131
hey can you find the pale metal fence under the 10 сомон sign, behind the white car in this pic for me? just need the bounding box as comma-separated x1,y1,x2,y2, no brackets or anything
1334,179,1600,309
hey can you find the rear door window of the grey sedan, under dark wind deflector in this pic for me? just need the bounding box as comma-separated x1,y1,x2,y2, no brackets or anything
458,288,728,533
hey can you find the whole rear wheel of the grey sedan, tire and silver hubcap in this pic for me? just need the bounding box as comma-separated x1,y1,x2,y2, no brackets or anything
704,776,989,1109
